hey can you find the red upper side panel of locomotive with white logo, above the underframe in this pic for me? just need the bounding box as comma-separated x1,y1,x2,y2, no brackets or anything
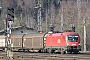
46,33,66,46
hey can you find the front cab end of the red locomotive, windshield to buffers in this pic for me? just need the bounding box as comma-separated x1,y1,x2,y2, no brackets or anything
66,32,81,53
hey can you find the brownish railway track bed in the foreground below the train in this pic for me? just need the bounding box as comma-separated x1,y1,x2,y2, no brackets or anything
0,52,90,60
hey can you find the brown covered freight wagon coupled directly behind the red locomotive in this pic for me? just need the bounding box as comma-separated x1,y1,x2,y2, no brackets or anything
23,33,44,51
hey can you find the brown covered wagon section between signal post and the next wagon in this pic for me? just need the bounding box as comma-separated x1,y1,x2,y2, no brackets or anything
11,34,23,50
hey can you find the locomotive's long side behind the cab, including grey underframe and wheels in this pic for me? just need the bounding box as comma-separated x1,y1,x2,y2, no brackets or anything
45,33,67,53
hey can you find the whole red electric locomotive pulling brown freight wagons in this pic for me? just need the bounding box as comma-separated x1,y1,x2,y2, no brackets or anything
45,32,81,53
